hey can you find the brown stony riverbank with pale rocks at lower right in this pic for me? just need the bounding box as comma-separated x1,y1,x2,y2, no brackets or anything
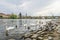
24,26,60,40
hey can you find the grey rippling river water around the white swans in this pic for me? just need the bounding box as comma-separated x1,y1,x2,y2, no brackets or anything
0,19,58,39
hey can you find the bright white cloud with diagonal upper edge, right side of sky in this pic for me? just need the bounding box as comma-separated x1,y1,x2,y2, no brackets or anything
36,1,60,16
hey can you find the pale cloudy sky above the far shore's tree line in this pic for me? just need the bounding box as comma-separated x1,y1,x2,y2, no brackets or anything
0,0,60,16
